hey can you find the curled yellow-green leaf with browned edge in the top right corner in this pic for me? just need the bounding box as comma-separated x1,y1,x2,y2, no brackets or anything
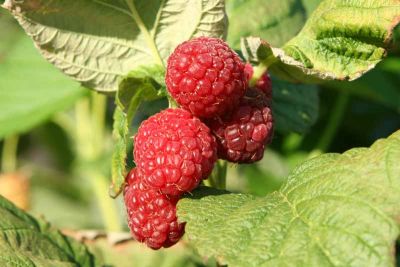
242,0,400,82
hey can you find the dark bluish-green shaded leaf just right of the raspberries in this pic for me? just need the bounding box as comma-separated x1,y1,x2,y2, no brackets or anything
272,76,319,133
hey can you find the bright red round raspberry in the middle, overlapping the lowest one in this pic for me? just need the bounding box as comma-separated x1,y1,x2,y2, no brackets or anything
134,109,217,195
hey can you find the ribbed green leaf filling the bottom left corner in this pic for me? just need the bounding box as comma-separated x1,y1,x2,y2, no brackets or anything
0,196,95,267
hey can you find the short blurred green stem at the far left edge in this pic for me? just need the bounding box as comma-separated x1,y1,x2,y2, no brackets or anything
1,135,19,173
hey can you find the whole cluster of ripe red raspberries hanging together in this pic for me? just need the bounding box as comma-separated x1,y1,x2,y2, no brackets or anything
124,37,273,249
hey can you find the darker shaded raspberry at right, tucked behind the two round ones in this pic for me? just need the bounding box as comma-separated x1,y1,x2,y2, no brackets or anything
208,88,273,163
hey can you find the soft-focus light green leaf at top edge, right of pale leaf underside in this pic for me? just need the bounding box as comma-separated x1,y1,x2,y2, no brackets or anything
226,0,306,48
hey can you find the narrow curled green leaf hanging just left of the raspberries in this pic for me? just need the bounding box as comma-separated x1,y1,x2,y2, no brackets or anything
110,65,167,197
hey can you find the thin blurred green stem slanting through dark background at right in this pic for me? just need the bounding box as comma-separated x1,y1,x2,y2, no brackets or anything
316,92,349,153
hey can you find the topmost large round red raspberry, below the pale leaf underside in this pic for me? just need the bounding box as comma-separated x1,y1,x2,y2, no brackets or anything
165,37,247,118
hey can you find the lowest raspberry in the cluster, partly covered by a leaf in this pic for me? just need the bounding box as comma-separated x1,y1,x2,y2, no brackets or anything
124,168,185,249
